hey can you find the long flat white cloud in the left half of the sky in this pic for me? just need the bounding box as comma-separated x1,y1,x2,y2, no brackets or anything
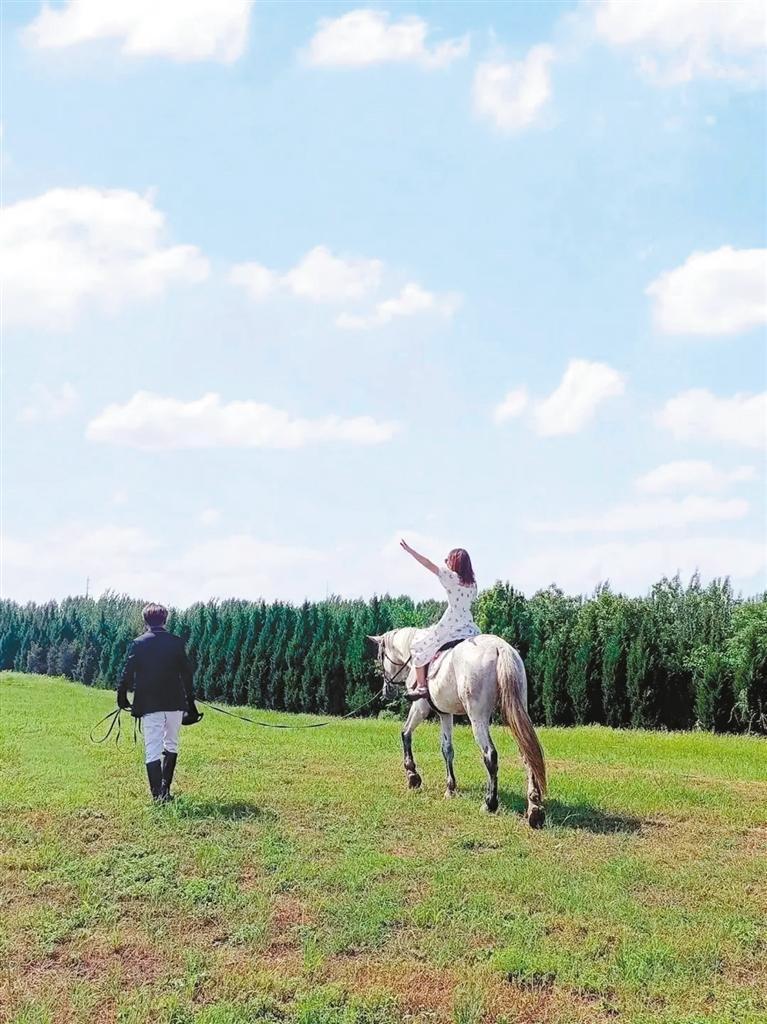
87,391,398,451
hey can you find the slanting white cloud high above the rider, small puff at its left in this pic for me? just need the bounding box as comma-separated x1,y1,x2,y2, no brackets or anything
494,359,626,437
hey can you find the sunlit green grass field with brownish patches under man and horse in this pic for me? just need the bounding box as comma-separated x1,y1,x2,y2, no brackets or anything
0,674,767,1024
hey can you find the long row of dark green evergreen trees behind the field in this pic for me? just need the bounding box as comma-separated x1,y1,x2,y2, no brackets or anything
0,578,767,732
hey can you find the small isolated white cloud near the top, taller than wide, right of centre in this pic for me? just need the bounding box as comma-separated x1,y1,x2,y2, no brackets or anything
473,45,554,132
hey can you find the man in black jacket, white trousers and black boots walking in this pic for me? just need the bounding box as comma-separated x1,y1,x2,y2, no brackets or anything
117,604,203,803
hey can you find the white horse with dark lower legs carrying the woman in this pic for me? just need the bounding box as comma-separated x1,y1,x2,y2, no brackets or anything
369,629,546,828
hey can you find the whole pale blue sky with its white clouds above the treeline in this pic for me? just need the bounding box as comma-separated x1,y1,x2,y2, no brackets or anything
1,0,767,603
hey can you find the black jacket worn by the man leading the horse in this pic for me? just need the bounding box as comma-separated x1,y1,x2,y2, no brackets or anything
117,629,195,718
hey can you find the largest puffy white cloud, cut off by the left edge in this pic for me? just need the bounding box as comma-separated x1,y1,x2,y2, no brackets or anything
0,188,208,328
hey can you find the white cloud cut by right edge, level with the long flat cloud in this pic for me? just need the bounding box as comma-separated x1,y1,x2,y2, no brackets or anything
655,388,767,449
